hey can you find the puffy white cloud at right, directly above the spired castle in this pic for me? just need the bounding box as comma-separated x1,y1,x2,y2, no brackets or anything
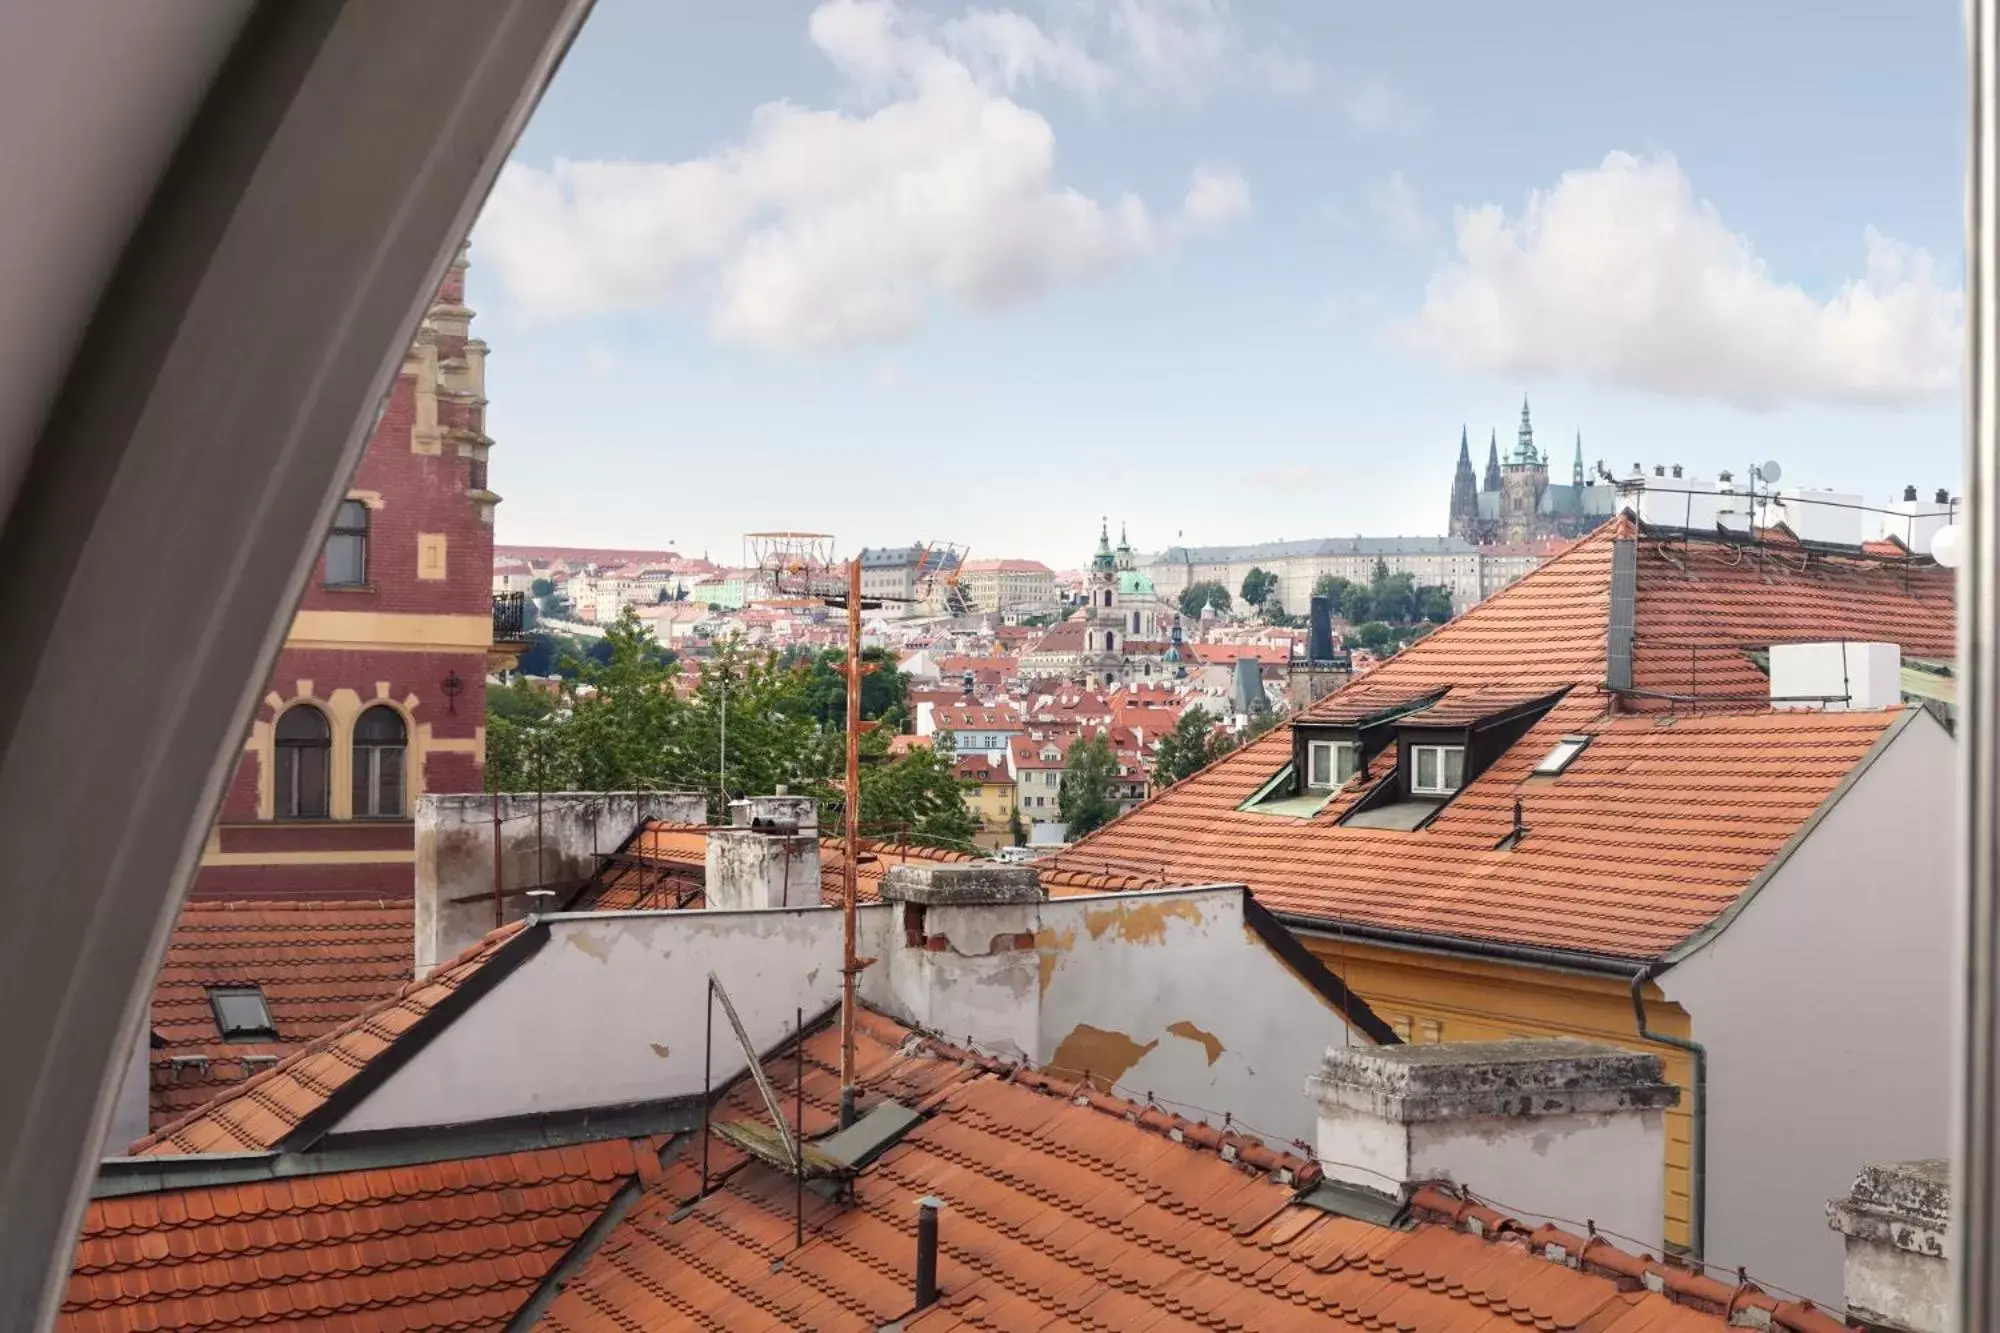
1402,152,1964,410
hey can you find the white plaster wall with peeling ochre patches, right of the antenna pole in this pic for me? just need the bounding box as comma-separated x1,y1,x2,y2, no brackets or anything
862,887,1366,1143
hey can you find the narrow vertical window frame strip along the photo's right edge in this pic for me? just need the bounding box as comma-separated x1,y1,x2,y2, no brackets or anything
1950,0,2000,1333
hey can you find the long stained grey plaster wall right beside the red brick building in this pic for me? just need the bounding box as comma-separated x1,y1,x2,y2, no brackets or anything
416,791,708,977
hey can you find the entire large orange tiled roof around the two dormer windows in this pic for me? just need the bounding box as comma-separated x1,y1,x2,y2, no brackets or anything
1042,516,1954,959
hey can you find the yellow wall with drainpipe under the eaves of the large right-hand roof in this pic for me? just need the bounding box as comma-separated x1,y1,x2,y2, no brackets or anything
1302,935,1692,1247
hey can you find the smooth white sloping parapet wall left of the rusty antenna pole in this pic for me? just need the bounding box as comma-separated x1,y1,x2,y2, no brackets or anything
336,907,844,1133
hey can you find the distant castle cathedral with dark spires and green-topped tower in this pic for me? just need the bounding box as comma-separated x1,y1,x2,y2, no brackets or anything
1448,398,1618,546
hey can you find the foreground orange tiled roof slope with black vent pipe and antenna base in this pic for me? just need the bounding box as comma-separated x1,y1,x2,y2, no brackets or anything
538,1015,1842,1333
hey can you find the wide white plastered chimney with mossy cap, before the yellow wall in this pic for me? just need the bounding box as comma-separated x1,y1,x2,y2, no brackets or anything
1306,1041,1680,1251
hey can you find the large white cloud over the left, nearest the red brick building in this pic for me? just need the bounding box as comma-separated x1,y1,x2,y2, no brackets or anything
478,0,1248,350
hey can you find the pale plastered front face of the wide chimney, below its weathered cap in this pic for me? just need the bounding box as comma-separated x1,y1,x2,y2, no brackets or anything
1408,1111,1672,1253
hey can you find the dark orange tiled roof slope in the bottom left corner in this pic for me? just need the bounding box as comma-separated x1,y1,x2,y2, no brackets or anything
56,1139,662,1333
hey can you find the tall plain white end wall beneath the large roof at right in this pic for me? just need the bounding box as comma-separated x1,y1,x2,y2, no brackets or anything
1660,713,1956,1309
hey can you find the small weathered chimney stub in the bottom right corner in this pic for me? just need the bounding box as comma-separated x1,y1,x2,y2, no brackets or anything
1826,1161,1952,1333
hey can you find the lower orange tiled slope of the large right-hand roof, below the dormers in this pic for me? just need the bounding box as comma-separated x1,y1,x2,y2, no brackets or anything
1044,695,1906,959
